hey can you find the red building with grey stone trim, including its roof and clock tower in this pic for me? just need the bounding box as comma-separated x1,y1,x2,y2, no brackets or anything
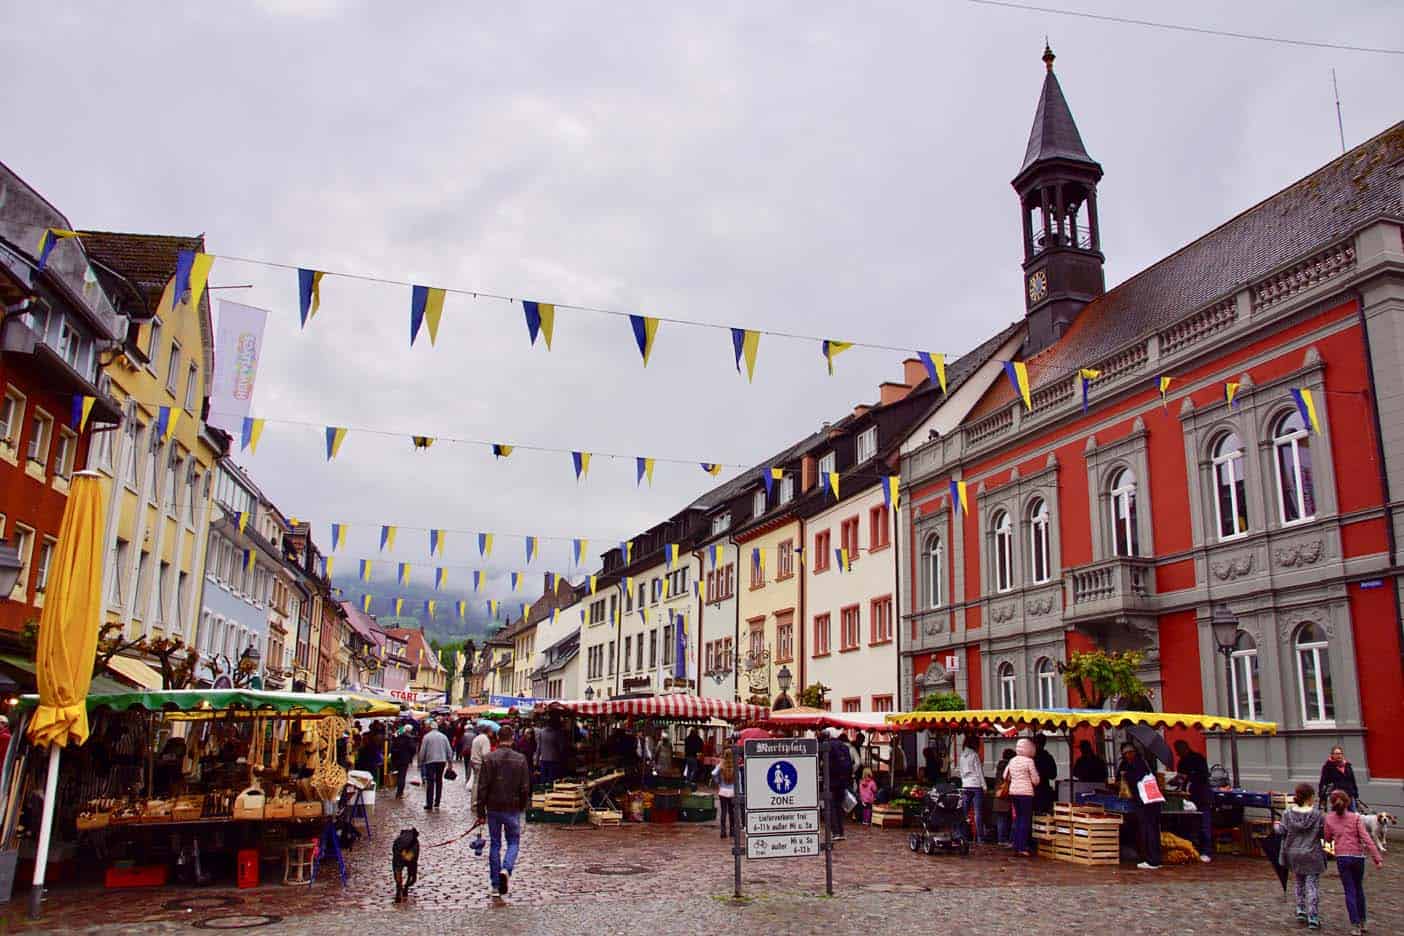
900,55,1404,804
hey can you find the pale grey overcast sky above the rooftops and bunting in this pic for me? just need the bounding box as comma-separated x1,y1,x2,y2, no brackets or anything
0,0,1404,634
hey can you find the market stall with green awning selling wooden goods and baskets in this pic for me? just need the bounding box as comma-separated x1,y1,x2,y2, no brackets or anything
0,689,399,887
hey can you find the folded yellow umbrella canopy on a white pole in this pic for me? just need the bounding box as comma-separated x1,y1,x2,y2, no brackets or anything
29,472,107,747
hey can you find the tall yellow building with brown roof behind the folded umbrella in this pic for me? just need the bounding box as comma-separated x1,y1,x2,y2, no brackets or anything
83,232,226,643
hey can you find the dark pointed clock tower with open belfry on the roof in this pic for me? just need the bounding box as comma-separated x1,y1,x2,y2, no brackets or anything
1012,44,1106,356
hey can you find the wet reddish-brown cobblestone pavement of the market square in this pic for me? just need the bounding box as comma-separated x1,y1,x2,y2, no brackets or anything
8,782,1404,936
